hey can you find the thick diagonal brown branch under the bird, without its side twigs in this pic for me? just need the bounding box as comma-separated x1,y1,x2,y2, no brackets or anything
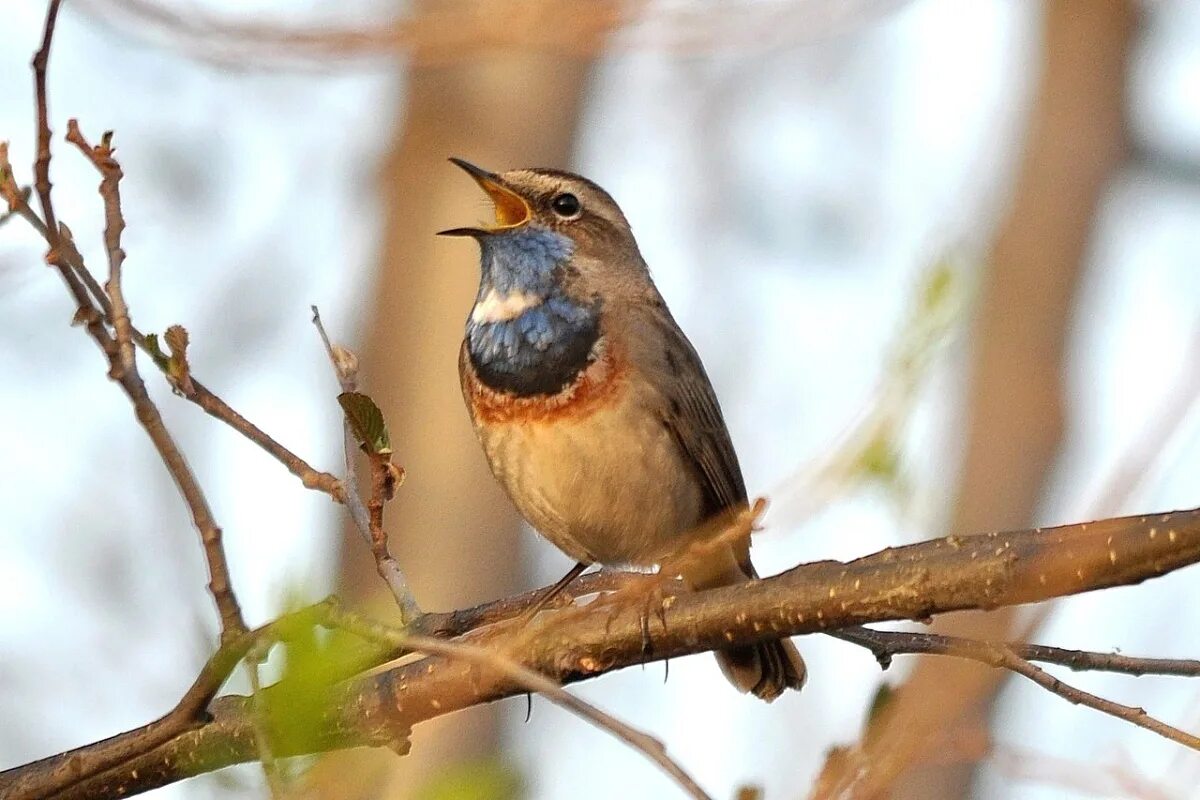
14,510,1200,799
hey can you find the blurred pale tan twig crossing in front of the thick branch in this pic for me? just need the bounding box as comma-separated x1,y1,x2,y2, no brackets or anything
331,610,712,800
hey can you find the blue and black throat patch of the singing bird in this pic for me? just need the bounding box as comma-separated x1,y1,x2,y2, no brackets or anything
467,224,600,397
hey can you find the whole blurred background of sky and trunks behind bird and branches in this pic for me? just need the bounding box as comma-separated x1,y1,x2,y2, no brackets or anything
0,0,1200,800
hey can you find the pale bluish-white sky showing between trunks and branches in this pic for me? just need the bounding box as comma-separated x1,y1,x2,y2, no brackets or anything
0,0,1200,800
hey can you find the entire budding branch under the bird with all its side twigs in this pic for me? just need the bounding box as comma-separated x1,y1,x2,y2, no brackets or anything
0,6,1200,800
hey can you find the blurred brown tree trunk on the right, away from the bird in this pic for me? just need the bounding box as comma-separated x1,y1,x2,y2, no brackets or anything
873,0,1138,799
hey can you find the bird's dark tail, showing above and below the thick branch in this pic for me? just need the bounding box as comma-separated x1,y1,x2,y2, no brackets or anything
685,548,808,703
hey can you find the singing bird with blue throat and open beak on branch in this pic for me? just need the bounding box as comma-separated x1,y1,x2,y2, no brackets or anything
440,158,806,702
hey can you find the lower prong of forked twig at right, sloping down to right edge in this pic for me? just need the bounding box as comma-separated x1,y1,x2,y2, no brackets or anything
830,628,1200,751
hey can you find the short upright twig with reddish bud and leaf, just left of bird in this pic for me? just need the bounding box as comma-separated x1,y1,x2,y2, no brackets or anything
312,306,421,622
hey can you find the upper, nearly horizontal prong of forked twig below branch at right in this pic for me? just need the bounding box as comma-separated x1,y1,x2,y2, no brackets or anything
829,627,1200,678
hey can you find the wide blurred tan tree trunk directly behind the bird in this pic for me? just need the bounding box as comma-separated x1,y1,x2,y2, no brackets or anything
302,14,597,799
